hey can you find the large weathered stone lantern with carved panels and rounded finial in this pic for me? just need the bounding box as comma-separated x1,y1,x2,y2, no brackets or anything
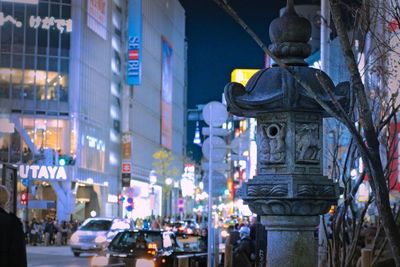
225,0,348,267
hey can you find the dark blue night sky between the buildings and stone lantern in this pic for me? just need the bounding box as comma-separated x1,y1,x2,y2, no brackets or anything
180,0,319,160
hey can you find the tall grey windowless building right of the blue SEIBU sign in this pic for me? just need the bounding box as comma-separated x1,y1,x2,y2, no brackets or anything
122,0,187,218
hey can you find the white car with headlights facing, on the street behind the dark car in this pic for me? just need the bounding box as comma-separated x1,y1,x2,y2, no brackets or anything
70,218,131,257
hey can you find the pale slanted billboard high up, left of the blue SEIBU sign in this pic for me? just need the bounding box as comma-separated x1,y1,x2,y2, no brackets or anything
87,0,107,40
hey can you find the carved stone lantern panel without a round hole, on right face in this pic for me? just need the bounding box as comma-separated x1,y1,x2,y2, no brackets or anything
296,123,322,164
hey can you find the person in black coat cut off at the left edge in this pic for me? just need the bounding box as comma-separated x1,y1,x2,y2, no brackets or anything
0,185,27,267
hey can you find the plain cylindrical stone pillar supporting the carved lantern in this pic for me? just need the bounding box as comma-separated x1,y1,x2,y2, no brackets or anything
261,216,319,267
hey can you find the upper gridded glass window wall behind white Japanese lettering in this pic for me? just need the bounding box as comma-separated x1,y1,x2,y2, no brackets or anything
0,0,71,105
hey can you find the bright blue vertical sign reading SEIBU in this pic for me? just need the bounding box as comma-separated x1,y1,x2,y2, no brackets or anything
126,0,142,85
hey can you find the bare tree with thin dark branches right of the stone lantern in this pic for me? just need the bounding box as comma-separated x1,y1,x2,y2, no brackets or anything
214,0,400,266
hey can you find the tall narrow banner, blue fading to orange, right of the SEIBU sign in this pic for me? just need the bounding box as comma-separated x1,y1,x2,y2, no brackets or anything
161,37,173,149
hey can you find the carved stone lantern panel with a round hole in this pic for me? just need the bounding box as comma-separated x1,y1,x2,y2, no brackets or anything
258,123,286,164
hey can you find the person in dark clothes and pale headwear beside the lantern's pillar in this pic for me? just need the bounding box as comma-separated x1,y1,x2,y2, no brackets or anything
233,225,255,267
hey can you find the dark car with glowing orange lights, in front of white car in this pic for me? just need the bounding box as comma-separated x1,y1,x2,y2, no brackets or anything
92,230,207,267
